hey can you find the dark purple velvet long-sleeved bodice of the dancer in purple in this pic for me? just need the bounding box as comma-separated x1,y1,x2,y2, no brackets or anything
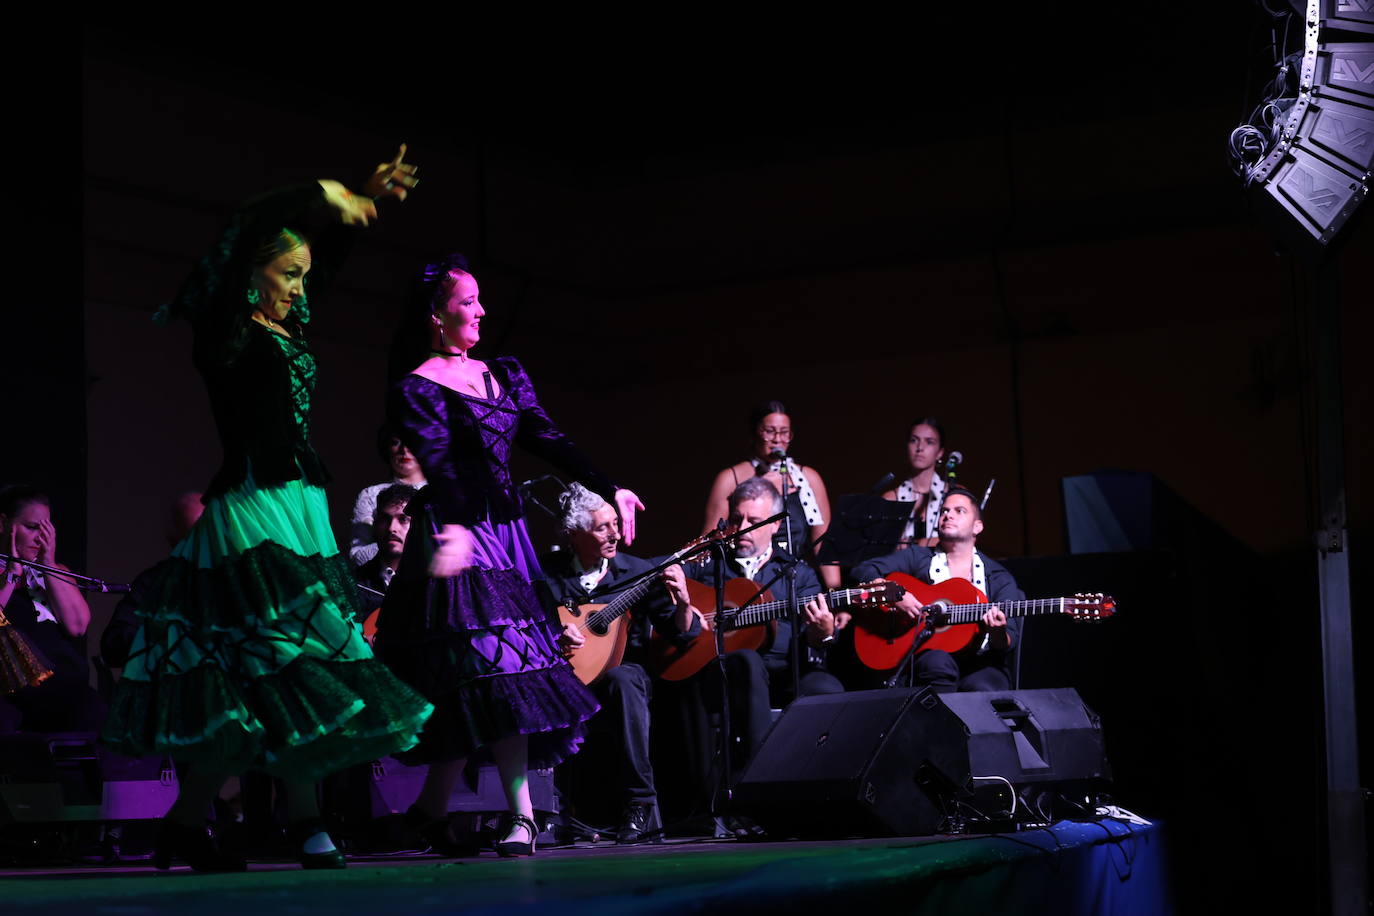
386,357,616,525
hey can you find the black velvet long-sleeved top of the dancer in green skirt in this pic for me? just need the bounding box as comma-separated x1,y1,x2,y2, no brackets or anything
161,183,353,497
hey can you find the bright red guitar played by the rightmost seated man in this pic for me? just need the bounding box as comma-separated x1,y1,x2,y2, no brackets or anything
853,573,1116,672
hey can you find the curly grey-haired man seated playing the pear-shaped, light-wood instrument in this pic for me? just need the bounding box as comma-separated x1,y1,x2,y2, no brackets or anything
540,483,697,846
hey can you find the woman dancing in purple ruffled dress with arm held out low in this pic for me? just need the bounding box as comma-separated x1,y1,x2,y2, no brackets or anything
376,255,644,856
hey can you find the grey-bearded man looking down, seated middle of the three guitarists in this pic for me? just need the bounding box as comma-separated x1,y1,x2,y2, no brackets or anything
686,477,844,768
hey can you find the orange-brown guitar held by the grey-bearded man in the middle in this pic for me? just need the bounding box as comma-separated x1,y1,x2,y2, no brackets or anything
649,578,901,681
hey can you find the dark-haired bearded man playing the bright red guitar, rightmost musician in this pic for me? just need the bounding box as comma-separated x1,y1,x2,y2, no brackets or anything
842,486,1025,694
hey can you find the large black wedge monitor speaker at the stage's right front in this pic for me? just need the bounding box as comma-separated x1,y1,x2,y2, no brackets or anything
734,688,1110,838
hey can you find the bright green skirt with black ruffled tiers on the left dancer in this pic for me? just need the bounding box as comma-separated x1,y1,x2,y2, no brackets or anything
102,478,433,780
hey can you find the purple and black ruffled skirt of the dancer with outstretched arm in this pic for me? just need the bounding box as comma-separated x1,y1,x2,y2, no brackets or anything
376,512,599,769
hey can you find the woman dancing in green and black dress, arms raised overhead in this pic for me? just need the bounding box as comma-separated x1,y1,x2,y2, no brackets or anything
102,146,431,871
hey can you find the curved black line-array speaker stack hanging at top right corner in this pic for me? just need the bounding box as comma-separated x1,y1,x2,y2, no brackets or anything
1231,0,1374,246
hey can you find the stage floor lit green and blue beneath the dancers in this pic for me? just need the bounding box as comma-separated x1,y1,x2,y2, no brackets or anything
0,820,1173,916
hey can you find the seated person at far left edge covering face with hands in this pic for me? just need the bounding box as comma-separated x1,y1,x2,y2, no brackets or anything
0,486,106,732
